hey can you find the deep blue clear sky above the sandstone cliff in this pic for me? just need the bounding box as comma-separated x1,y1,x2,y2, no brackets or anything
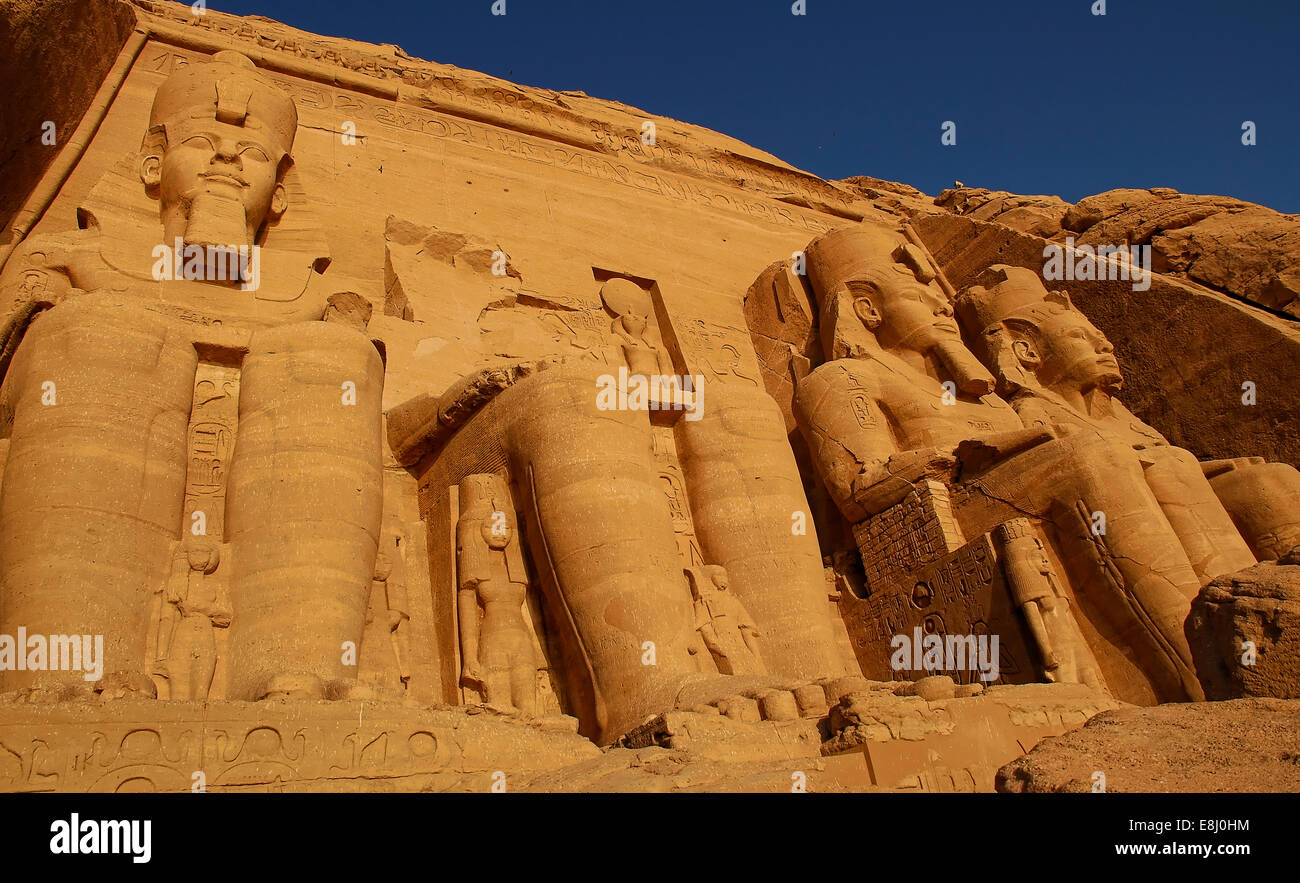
209,0,1300,212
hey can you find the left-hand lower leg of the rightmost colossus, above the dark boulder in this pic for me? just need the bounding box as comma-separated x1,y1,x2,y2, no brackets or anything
1138,447,1256,583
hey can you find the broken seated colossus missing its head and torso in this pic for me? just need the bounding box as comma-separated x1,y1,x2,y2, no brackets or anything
389,280,845,744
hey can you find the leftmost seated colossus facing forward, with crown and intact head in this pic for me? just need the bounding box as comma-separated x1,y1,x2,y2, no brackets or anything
0,51,384,700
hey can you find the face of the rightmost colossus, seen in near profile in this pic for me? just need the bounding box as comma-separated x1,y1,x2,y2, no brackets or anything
1013,310,1123,391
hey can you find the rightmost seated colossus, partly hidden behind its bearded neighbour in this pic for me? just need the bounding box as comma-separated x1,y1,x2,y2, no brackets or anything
958,265,1300,566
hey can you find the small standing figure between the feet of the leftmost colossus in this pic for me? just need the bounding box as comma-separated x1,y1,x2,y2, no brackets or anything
153,537,233,700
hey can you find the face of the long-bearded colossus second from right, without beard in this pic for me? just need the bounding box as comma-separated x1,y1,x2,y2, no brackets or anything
846,263,961,352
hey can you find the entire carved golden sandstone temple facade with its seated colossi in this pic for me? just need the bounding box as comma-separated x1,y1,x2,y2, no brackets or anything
0,0,1300,791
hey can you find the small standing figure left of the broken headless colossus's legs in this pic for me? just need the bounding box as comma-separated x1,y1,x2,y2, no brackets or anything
456,475,538,715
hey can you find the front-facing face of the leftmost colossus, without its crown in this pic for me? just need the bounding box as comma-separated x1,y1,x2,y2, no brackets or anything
146,117,285,241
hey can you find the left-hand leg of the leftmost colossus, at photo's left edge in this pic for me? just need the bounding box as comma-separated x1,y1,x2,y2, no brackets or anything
0,294,198,694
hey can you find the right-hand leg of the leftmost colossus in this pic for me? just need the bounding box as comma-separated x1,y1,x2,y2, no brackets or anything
226,323,384,700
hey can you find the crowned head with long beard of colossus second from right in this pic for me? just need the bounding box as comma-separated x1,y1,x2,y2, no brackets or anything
805,224,992,395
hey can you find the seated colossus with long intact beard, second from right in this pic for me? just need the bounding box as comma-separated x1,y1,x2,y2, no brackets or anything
794,225,1203,704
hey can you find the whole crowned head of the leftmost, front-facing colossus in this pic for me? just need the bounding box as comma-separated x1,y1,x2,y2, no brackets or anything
139,51,298,247
